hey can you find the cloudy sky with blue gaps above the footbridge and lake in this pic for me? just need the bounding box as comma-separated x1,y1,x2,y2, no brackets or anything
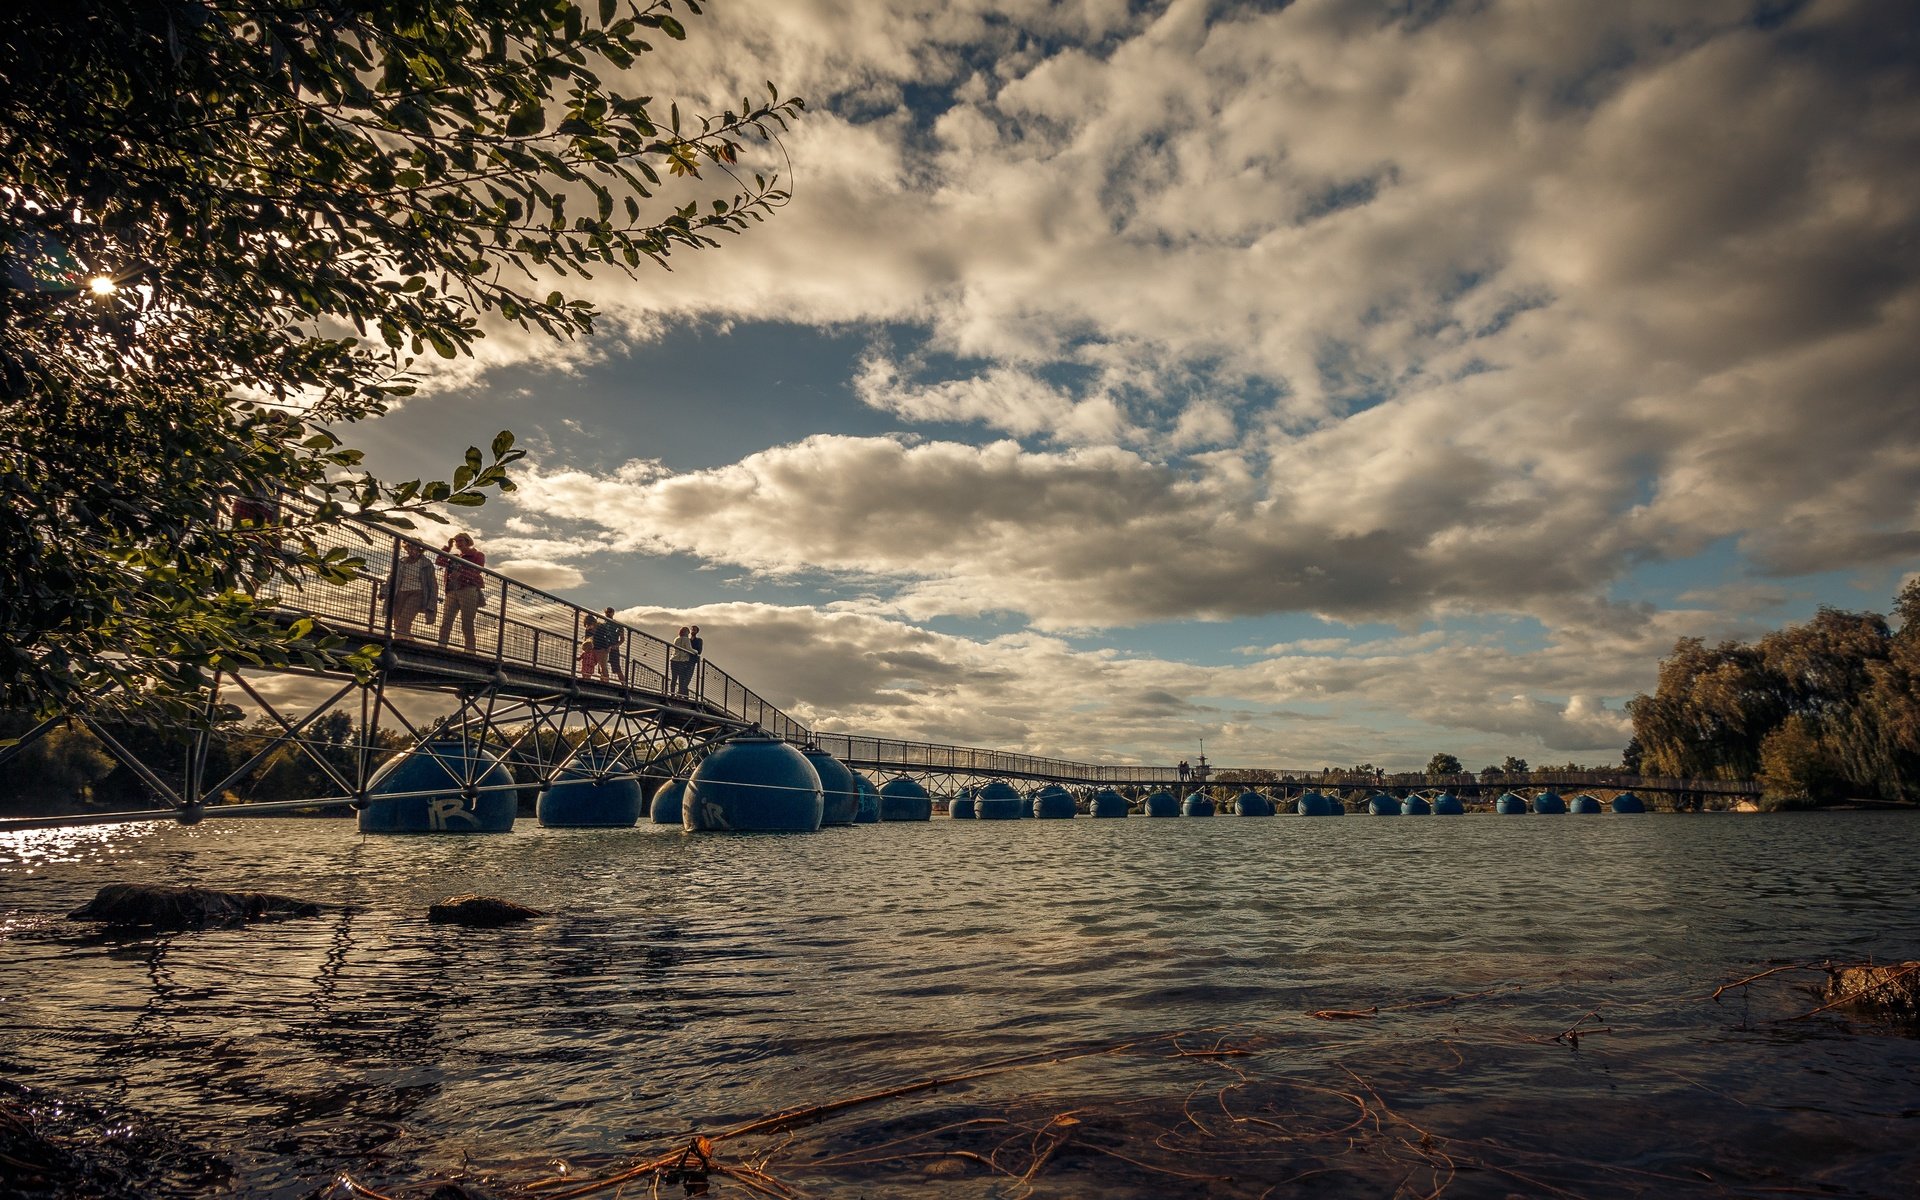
351,0,1920,770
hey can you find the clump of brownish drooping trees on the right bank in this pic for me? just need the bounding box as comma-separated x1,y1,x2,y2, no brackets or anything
1628,580,1920,806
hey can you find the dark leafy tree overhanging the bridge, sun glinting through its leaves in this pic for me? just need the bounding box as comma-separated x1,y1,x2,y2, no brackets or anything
0,0,801,712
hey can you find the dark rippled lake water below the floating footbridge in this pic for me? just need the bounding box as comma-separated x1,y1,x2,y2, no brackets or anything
0,812,1920,1198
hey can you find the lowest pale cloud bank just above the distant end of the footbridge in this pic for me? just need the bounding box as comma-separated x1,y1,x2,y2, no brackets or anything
618,603,1630,770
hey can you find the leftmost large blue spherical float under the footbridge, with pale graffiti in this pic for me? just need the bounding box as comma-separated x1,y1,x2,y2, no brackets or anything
359,737,520,833
